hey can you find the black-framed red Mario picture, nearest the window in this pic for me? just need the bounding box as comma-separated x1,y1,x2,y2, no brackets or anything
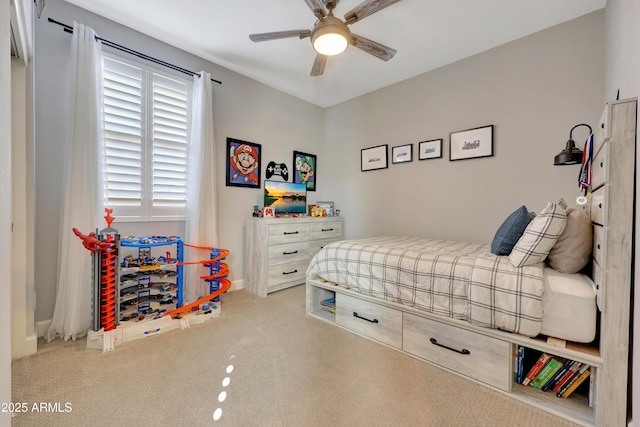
227,138,262,188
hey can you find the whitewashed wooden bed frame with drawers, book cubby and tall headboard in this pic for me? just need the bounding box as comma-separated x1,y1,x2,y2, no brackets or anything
306,99,637,427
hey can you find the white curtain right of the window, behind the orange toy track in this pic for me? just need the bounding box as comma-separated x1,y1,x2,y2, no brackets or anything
184,71,219,302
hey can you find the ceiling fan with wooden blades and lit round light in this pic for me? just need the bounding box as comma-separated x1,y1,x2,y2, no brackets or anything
249,0,400,76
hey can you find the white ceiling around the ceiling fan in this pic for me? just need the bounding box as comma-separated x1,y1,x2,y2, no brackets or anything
60,0,606,107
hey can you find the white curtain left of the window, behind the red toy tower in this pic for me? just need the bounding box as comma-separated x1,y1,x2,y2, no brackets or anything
45,22,106,341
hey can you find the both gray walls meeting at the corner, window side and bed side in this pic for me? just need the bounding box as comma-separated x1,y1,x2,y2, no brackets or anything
35,0,604,321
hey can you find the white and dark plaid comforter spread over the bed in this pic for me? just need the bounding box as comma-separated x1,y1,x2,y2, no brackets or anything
307,237,544,336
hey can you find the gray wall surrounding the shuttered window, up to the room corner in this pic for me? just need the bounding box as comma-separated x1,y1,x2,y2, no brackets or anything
35,0,326,321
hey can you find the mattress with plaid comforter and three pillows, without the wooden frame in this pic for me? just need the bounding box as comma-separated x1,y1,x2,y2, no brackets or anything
307,202,597,342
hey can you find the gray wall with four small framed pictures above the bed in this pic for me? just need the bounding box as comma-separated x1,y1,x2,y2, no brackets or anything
321,11,604,242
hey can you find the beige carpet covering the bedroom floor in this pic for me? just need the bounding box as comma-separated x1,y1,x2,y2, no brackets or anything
12,286,573,427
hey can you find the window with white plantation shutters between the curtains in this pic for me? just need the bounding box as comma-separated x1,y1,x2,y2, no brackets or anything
103,55,192,218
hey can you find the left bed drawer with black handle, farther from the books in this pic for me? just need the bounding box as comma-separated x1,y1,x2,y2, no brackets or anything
336,294,402,349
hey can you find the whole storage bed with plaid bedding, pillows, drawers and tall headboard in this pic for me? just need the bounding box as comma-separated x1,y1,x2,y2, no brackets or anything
306,99,637,426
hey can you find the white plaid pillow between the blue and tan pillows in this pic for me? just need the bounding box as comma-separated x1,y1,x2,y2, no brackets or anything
509,202,567,267
